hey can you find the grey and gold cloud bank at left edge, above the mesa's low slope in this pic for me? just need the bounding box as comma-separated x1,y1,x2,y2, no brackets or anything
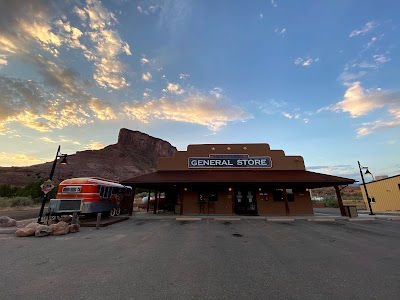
0,72,116,132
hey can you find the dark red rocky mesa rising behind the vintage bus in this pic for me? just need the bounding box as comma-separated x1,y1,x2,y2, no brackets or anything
0,128,177,186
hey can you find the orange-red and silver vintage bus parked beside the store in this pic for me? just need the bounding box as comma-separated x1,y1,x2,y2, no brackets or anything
48,177,132,216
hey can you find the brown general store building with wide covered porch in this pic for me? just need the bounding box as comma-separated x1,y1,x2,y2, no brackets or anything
123,144,355,215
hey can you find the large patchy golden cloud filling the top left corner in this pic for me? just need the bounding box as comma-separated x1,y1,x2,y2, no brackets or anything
0,0,131,89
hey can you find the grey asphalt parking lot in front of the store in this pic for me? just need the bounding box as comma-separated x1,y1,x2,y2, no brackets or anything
0,219,400,299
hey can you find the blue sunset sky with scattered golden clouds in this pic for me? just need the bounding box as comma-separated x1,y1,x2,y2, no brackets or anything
0,0,400,181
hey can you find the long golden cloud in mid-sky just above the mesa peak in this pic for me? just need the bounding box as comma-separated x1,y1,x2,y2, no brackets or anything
124,92,251,131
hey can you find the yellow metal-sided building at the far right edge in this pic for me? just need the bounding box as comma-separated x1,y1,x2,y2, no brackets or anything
361,175,400,212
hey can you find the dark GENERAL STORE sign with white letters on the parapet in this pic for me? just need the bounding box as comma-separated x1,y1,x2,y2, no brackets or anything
188,154,272,169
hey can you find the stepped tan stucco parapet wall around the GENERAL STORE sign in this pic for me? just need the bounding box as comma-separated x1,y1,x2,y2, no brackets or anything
157,144,305,171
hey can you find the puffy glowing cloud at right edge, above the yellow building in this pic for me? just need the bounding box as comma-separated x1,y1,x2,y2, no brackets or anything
330,82,400,137
